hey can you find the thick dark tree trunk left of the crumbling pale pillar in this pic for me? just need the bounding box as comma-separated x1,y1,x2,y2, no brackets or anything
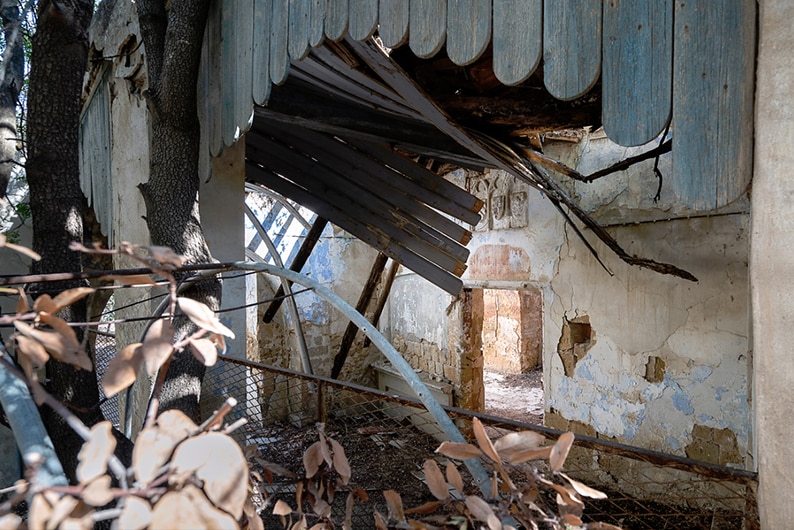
26,0,110,479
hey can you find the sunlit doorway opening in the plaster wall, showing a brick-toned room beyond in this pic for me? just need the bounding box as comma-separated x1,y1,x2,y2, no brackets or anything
474,288,544,424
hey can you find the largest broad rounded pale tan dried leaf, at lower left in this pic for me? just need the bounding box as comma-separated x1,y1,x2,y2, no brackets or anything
171,432,248,519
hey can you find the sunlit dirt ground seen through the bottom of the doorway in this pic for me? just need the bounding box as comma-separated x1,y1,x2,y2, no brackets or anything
483,367,543,425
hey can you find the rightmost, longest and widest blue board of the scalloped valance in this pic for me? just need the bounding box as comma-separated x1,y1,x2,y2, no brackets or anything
672,0,756,209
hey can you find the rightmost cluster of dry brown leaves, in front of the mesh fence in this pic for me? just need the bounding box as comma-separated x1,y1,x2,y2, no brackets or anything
375,418,620,530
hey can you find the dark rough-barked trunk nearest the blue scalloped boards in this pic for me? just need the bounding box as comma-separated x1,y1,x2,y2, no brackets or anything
137,0,221,419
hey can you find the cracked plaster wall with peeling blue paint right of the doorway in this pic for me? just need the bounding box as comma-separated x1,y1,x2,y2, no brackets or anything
544,133,752,467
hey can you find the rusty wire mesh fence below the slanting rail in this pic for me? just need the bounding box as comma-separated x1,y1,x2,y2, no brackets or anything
201,359,758,530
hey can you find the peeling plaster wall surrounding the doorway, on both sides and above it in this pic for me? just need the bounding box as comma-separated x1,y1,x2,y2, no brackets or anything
389,134,752,467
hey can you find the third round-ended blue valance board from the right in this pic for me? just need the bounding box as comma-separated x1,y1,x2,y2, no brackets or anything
543,0,601,100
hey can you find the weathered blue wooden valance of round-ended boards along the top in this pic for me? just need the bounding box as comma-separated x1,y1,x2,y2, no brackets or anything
200,0,756,209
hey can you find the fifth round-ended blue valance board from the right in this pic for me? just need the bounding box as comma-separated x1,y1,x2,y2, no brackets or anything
447,0,491,65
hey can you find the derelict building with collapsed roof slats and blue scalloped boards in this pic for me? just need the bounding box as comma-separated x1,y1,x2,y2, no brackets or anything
0,0,794,528
